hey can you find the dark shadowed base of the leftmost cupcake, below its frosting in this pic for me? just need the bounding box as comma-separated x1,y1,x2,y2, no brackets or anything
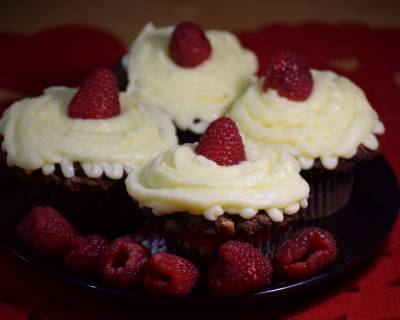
3,155,143,237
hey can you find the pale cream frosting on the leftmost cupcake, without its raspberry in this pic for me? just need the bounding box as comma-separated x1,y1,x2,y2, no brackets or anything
0,87,177,179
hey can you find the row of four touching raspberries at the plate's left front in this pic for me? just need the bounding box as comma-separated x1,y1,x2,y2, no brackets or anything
16,207,199,295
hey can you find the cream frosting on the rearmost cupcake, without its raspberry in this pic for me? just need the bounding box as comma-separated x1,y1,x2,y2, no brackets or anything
127,24,258,133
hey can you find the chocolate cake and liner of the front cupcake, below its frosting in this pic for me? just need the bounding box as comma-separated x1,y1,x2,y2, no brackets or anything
155,212,295,269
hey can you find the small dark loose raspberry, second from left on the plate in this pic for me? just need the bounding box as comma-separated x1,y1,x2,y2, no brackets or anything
64,235,108,274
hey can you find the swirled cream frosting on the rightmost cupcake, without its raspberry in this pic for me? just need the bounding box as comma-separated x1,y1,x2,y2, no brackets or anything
230,70,384,169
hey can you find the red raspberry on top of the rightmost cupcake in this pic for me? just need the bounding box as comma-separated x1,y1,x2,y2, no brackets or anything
263,50,313,101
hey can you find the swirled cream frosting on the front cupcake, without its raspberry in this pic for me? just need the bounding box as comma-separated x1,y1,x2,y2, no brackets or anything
125,144,309,222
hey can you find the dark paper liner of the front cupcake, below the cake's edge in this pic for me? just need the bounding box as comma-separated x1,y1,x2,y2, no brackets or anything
162,220,294,269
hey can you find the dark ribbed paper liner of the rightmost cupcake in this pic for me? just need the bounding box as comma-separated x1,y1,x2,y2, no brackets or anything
298,169,354,220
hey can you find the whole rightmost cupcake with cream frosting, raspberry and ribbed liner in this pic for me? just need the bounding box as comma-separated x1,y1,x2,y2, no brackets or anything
229,51,384,219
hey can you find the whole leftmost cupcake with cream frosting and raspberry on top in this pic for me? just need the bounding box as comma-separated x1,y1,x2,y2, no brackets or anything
0,68,177,233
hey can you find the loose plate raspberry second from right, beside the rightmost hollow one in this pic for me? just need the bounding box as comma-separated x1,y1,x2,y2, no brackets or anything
208,240,272,296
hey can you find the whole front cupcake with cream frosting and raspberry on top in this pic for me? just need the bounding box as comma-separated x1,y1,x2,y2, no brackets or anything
126,117,309,267
